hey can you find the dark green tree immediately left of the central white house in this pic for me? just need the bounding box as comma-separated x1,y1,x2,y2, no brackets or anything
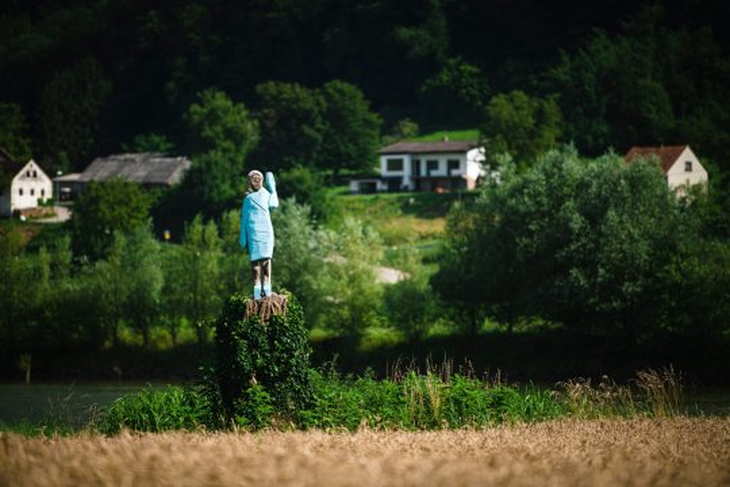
319,80,382,176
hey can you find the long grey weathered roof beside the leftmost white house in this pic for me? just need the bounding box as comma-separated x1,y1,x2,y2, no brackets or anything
78,152,190,186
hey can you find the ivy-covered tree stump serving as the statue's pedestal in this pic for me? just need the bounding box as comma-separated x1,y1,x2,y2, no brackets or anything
215,294,312,426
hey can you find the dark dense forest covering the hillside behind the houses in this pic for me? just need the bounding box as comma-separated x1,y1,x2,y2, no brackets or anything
0,0,730,180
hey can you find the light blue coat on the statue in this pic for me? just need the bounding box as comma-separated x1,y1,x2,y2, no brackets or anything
239,172,279,261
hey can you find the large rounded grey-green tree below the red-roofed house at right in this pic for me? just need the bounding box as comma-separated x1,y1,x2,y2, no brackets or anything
434,149,685,339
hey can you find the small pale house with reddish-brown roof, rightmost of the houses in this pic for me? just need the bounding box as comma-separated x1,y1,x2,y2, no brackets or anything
625,145,708,196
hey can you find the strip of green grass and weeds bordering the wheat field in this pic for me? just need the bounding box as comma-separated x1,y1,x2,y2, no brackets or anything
84,361,682,434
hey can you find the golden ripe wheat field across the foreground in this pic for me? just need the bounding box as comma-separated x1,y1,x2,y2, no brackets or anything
0,417,730,486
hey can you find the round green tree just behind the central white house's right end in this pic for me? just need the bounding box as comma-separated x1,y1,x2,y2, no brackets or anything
480,90,561,172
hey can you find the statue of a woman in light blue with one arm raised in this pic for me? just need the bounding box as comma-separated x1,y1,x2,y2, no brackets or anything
239,171,279,299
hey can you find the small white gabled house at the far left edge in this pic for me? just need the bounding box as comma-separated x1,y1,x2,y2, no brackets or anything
0,158,53,216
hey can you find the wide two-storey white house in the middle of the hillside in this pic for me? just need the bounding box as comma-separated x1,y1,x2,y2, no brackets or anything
351,140,484,192
